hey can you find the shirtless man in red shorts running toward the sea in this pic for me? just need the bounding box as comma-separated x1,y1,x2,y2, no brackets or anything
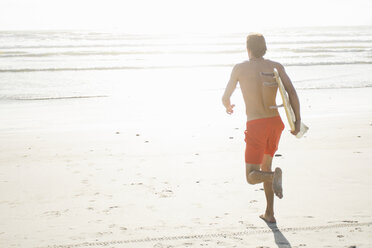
222,34,301,223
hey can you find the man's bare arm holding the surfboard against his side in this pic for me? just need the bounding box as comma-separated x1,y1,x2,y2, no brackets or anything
276,64,301,135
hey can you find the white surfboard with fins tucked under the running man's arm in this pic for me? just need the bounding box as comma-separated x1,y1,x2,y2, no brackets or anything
274,69,309,138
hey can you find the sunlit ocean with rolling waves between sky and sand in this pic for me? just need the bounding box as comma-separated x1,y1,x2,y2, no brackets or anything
0,26,372,101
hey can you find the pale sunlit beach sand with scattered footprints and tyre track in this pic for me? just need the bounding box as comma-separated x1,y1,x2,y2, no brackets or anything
0,88,372,248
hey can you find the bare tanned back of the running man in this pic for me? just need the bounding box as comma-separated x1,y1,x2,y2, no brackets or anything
236,59,279,121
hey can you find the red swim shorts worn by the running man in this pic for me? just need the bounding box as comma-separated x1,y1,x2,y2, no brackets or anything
244,116,284,164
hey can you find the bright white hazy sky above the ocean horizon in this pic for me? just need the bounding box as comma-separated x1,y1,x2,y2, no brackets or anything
0,0,372,32
